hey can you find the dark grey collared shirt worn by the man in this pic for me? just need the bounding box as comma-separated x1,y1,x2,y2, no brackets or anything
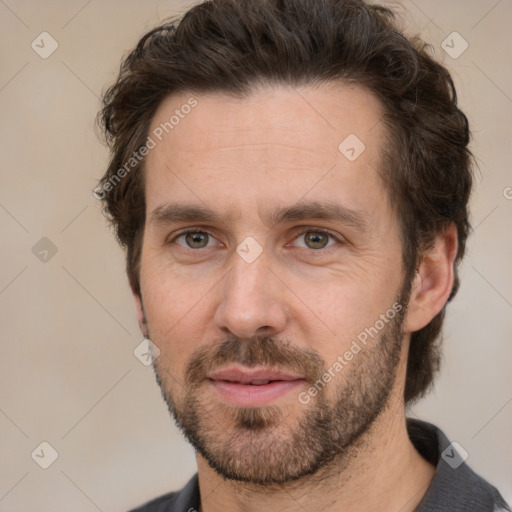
131,419,511,512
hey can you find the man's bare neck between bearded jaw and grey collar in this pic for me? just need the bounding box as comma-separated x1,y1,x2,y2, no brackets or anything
197,400,434,512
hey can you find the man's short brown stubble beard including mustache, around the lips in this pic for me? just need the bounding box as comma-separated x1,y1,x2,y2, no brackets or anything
154,297,407,487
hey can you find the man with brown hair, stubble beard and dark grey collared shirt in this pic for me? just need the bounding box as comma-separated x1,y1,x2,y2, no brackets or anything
96,0,509,512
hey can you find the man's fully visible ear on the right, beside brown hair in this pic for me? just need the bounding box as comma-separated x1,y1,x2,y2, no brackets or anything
404,223,458,333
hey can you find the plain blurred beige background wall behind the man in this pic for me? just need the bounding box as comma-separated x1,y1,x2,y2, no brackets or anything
0,0,512,512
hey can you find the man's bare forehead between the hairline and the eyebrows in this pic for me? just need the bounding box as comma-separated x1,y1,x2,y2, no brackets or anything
146,83,384,219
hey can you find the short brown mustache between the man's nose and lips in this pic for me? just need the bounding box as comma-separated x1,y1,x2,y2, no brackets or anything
185,335,326,386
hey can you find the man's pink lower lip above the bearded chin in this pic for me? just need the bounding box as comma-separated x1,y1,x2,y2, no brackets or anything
210,379,306,407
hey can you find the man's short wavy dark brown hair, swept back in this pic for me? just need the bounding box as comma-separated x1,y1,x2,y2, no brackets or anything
96,0,472,402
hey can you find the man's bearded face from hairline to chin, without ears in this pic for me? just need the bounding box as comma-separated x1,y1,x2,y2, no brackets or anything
140,84,407,484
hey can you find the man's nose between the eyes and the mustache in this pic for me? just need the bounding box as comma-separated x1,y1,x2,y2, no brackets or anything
214,253,287,338
